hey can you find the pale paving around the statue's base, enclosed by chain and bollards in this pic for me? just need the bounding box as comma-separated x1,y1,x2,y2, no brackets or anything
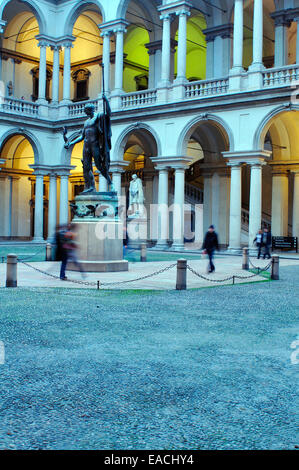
0,253,299,290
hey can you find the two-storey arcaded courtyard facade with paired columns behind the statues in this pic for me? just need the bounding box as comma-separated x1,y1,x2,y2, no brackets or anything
0,0,299,250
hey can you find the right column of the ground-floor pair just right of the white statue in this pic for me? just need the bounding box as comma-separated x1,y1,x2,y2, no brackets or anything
172,167,185,251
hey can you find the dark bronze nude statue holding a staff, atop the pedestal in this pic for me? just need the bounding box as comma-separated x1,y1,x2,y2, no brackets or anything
63,93,113,194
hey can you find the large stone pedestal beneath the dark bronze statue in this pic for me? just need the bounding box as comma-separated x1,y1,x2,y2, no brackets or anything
68,192,129,272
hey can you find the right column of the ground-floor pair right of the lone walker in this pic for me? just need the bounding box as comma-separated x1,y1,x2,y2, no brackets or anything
248,162,262,248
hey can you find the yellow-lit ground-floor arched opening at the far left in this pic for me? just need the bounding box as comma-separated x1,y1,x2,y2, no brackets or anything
0,134,49,240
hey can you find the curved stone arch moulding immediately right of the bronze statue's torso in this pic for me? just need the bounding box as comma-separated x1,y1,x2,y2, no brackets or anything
112,123,162,161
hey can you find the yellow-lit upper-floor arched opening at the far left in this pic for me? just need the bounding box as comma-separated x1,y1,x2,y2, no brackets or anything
1,1,52,101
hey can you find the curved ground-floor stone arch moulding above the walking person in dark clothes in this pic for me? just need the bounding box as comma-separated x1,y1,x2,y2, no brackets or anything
177,114,234,155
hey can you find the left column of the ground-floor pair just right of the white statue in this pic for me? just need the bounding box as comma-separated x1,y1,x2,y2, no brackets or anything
156,167,169,249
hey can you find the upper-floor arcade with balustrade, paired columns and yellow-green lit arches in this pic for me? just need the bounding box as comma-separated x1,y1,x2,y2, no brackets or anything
0,0,299,119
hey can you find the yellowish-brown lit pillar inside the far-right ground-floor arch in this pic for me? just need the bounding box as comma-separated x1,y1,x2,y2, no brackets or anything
271,166,289,236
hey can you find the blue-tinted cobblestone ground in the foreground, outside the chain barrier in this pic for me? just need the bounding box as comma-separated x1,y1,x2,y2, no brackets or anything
0,266,299,450
